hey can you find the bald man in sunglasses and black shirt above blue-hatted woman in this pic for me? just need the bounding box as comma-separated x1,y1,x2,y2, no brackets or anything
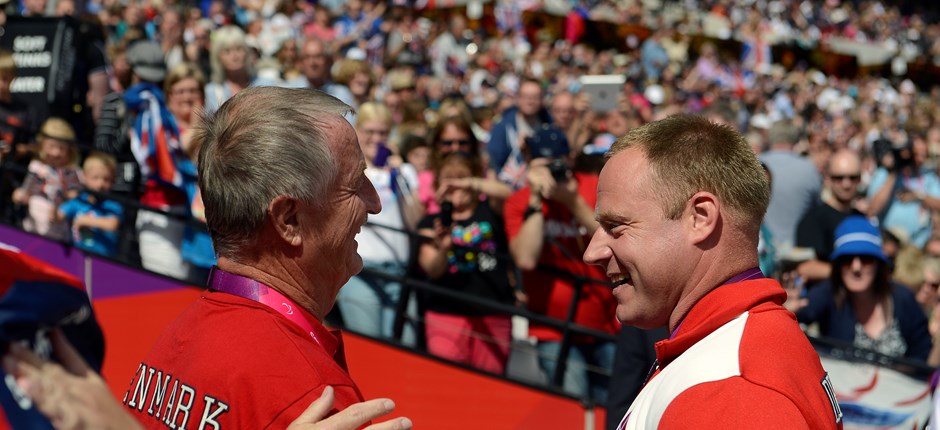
796,149,862,288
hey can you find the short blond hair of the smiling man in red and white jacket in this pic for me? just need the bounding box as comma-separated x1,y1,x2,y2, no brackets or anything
607,115,770,233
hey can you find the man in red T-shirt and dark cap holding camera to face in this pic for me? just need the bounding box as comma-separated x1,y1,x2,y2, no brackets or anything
504,125,619,400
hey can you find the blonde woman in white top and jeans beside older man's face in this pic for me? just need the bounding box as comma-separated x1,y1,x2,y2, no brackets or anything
337,103,423,344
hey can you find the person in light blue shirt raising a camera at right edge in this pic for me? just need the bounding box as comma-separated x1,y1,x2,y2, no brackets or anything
868,139,940,248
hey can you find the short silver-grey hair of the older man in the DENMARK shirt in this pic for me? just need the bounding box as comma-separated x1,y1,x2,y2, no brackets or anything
193,87,352,258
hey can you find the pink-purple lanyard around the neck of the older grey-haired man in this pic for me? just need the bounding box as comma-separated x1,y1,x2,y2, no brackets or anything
208,267,323,347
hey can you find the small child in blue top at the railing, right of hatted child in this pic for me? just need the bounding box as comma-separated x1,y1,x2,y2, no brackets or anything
57,152,124,257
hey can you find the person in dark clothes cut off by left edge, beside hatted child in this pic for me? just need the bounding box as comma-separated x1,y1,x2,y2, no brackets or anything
0,49,36,222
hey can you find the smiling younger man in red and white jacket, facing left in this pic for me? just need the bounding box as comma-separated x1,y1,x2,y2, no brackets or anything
584,116,841,429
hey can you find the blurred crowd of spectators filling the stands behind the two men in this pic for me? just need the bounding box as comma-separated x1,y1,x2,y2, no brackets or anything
0,0,940,399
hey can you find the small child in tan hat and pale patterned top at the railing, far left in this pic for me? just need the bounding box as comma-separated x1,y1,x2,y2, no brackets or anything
13,118,82,241
